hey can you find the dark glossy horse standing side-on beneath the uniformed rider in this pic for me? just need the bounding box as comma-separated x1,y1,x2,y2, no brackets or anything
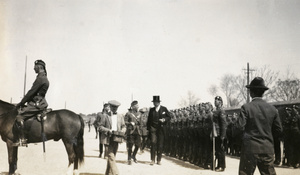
0,100,84,174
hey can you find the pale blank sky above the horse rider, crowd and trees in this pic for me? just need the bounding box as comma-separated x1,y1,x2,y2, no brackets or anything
0,0,300,114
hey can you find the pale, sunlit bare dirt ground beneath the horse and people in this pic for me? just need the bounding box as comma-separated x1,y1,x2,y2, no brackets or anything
0,127,300,175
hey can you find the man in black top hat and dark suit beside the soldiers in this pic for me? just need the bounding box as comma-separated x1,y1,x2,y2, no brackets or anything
147,96,171,165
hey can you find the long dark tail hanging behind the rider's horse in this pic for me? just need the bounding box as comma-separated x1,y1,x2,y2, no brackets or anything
74,115,84,164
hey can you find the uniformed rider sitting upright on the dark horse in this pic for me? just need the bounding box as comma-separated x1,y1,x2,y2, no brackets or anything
14,60,49,146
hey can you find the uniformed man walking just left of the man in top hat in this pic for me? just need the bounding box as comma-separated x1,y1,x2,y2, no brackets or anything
125,100,141,165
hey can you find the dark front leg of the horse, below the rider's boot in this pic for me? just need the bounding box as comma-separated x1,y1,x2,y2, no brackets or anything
6,141,18,174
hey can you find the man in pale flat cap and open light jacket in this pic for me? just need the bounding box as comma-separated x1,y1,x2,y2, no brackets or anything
100,100,126,175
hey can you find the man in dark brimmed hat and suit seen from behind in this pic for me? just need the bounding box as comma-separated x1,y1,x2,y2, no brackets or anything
237,77,282,175
